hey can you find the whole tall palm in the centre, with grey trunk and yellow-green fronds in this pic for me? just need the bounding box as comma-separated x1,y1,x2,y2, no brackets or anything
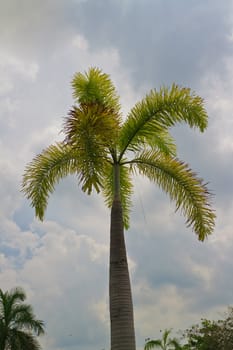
22,68,215,350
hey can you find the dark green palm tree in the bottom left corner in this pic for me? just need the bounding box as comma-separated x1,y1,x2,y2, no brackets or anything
0,288,44,350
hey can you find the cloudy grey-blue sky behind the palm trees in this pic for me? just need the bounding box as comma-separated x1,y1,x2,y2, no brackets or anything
0,0,233,350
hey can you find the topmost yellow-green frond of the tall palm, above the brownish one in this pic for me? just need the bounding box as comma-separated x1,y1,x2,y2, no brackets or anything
71,68,120,114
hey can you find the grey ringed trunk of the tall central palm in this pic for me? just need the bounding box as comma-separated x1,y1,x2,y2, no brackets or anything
109,196,136,350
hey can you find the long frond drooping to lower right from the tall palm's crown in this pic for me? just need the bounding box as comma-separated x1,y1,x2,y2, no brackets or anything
131,151,215,241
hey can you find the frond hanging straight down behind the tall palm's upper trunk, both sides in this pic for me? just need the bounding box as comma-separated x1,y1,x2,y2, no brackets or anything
102,164,133,229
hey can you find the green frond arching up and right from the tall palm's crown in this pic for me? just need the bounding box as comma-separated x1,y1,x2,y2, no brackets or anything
119,84,208,155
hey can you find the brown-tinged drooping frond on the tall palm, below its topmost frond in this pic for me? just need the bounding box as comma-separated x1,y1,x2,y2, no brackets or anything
63,105,116,194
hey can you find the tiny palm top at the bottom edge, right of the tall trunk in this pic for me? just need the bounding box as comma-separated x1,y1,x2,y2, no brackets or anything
144,329,183,350
